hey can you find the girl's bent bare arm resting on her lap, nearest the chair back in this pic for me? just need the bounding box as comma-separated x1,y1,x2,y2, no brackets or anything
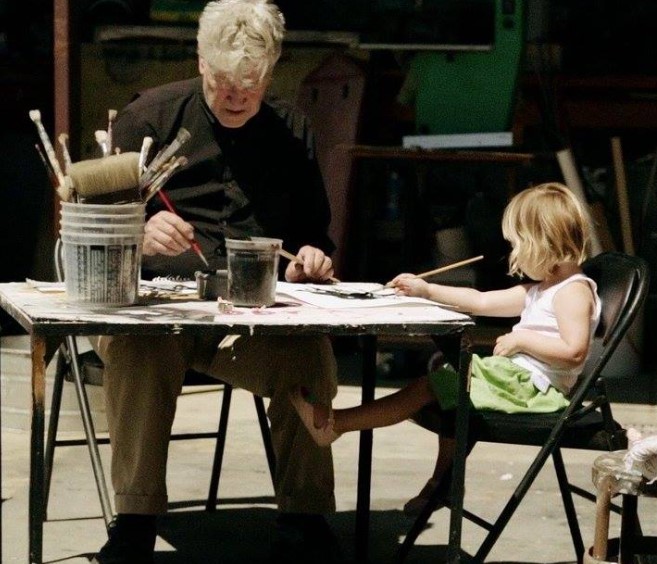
493,281,594,368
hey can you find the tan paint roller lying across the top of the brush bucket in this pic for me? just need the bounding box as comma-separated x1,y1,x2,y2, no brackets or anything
68,152,141,204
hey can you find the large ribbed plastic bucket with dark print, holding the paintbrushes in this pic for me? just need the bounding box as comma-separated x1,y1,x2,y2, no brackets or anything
60,204,145,306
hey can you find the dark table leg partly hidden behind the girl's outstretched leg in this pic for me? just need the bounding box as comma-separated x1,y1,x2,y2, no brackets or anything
356,336,376,563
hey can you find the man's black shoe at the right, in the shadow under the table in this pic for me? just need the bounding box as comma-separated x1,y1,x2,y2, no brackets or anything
270,513,346,564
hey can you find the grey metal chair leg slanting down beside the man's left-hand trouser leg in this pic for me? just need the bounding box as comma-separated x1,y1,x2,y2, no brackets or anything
66,337,114,527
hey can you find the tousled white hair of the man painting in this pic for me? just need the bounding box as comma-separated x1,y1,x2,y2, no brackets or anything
197,0,285,87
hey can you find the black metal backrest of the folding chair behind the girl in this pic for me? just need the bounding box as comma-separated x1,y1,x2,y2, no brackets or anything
571,252,650,405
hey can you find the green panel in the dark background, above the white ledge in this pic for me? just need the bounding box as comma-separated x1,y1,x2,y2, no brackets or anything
410,0,525,134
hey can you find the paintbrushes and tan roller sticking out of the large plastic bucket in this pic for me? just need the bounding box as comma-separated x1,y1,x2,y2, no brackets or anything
30,110,190,204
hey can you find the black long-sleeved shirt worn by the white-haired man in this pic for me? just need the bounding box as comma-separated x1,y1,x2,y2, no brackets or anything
112,78,334,276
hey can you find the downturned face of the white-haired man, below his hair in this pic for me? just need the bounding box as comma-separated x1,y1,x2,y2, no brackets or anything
199,59,269,128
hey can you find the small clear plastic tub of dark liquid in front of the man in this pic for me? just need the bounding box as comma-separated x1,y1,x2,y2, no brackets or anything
226,237,283,307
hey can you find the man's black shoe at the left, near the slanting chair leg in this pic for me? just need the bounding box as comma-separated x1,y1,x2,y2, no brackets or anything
91,513,157,564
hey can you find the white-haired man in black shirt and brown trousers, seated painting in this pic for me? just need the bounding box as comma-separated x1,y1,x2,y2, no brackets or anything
95,0,339,564
